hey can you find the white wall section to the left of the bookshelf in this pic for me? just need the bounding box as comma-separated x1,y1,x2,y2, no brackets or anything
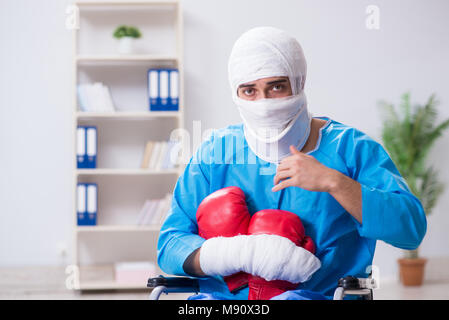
0,0,73,265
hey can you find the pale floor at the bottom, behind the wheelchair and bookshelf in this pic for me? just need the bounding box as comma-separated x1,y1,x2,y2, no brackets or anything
0,267,449,300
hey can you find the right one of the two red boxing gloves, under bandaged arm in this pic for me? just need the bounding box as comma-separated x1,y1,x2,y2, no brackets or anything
248,209,315,300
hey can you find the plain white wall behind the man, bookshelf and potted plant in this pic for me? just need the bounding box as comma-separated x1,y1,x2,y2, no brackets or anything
0,0,449,277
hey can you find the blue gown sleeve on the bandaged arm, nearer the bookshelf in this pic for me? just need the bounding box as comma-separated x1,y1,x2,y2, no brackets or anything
157,138,212,276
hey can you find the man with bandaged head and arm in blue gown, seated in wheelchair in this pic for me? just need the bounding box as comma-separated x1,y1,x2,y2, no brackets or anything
158,27,426,299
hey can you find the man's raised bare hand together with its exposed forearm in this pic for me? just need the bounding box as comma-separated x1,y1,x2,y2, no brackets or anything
271,146,362,223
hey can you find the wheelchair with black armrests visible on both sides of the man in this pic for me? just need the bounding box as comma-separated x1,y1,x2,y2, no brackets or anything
147,275,377,300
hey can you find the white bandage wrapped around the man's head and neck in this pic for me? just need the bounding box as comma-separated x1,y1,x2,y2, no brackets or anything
228,27,311,163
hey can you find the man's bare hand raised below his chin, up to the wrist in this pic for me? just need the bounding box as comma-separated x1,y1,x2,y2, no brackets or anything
272,146,338,192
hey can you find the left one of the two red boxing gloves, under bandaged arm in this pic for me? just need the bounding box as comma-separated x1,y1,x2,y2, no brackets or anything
196,187,251,292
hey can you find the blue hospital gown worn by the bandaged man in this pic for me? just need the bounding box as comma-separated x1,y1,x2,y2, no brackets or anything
158,118,427,299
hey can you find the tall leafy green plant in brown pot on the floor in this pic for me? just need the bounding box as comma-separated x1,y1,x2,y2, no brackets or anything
379,93,449,286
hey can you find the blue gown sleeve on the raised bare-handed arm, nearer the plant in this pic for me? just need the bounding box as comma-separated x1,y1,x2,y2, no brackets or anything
346,133,427,250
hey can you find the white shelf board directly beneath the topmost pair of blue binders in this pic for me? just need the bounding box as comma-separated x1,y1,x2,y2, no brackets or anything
76,111,181,120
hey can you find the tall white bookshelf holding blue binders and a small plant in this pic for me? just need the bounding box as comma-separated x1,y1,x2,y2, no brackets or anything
72,1,184,290
